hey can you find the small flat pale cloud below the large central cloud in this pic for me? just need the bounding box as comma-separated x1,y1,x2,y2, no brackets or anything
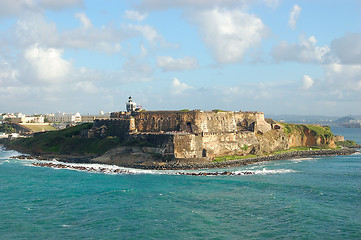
157,56,198,72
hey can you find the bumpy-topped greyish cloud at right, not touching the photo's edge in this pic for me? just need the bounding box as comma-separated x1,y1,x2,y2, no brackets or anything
272,36,330,63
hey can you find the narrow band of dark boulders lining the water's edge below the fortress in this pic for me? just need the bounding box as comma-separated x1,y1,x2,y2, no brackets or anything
8,148,358,170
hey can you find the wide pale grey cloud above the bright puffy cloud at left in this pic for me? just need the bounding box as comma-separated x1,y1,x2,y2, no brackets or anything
13,13,134,54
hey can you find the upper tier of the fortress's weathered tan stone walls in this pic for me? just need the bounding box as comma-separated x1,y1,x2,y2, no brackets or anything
105,111,271,134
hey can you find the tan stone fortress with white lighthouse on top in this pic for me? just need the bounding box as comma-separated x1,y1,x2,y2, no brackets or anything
94,97,286,160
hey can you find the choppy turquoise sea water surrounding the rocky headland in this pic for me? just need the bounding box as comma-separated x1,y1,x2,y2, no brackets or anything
0,128,361,239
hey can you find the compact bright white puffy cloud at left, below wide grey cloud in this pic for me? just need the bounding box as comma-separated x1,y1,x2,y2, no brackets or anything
24,45,71,83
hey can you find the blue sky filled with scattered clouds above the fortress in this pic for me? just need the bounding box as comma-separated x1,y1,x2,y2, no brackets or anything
0,0,361,116
